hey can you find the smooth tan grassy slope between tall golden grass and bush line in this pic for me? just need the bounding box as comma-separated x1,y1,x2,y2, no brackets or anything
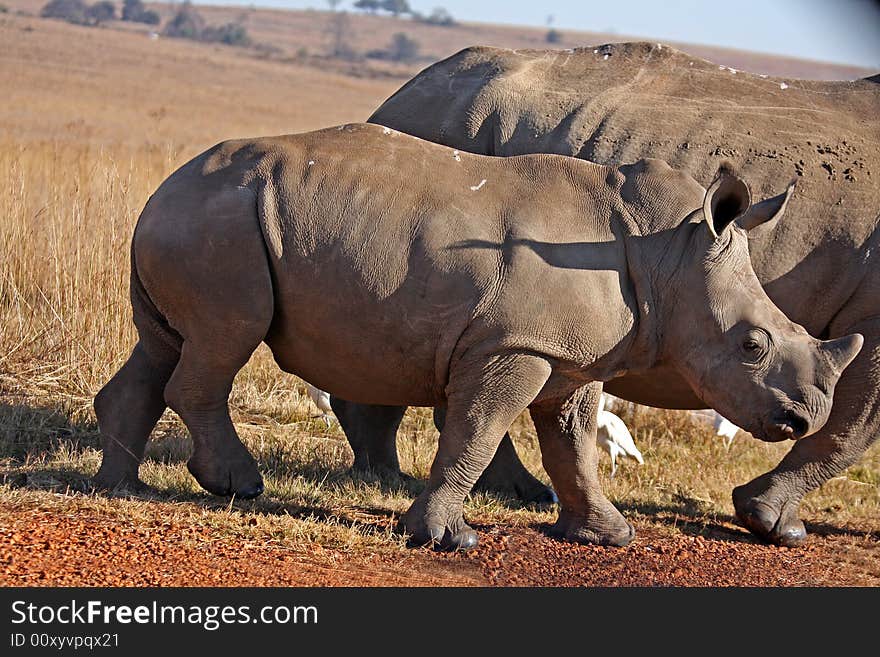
0,8,400,147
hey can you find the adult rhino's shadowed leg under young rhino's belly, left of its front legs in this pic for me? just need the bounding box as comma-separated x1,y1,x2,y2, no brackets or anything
330,395,406,477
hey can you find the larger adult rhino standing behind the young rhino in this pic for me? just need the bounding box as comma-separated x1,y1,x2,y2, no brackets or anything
331,43,880,546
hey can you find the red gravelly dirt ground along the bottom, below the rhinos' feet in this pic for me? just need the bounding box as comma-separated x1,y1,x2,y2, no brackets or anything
0,505,880,586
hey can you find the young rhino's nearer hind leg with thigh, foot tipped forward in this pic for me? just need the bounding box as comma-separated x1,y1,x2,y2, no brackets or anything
135,204,275,499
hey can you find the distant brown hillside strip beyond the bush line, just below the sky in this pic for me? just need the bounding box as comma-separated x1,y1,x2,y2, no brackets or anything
3,0,876,80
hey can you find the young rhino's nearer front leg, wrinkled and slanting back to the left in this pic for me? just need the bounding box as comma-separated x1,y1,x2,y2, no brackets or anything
400,354,550,550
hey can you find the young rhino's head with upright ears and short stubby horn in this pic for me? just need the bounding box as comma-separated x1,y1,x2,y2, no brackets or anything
666,169,863,441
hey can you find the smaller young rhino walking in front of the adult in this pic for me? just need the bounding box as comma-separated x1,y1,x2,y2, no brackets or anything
95,125,862,549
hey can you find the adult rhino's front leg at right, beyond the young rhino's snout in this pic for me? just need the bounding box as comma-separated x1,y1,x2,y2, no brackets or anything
733,320,880,547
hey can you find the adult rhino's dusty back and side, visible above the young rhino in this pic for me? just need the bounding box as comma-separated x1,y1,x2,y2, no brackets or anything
370,43,880,333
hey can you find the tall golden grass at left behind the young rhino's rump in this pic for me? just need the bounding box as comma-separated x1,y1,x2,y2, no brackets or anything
0,142,178,401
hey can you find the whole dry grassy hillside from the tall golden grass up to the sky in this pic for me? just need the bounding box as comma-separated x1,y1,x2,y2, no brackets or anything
0,0,866,156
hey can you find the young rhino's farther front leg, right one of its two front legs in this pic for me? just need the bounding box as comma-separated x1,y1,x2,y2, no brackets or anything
529,384,635,546
